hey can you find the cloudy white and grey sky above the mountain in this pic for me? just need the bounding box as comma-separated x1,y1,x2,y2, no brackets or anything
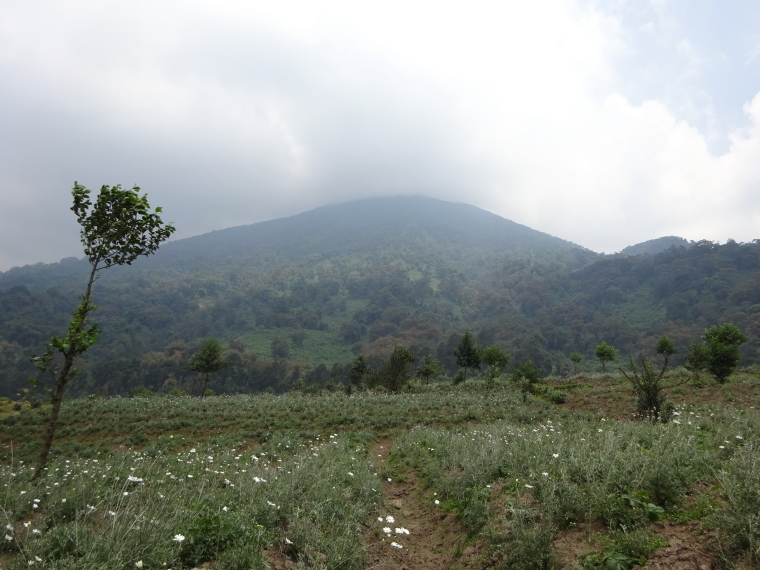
0,0,760,271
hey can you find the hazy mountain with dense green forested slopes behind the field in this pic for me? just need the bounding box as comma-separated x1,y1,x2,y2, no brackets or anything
0,197,760,396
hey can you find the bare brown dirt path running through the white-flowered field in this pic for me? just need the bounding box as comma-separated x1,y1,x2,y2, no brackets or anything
366,440,490,570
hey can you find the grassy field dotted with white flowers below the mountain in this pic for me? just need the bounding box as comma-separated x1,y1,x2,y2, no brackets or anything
0,369,760,570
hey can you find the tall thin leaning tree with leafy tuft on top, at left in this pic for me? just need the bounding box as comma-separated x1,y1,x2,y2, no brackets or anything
31,182,174,479
